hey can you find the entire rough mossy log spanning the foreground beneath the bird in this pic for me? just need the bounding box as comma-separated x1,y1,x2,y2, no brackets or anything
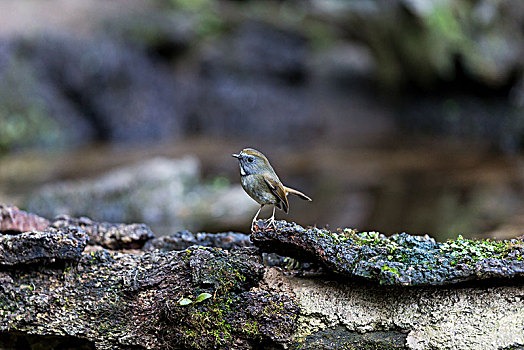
0,209,524,349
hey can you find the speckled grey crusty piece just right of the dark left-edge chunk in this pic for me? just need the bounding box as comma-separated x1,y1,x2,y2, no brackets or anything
51,215,154,250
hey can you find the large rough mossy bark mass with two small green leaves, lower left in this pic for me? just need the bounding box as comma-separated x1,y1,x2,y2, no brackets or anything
0,231,297,349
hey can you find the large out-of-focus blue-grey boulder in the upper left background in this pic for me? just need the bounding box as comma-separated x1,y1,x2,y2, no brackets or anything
17,36,184,142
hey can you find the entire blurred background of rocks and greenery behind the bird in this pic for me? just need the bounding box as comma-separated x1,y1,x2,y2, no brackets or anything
0,0,524,240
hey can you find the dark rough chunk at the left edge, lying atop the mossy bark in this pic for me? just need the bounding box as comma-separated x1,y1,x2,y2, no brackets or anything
0,226,87,266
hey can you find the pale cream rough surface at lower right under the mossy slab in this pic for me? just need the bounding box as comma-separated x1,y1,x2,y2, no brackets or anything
264,269,524,350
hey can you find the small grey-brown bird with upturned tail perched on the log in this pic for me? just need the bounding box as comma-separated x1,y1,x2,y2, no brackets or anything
233,148,311,230
